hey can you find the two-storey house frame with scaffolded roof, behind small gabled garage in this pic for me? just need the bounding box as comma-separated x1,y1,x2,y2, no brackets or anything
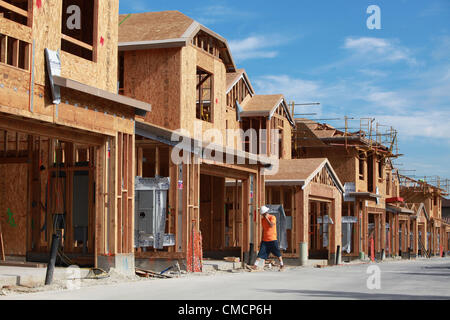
292,119,398,259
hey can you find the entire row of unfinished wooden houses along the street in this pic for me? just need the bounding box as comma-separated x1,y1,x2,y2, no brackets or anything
0,0,450,280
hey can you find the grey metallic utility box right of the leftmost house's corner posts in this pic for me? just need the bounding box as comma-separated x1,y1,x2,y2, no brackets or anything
134,177,175,249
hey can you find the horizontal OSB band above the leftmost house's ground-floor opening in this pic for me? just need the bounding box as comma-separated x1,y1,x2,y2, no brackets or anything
0,65,134,135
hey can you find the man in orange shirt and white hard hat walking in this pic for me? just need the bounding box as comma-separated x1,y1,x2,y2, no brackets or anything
249,206,284,271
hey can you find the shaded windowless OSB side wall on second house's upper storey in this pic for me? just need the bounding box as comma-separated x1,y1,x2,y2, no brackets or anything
124,48,182,130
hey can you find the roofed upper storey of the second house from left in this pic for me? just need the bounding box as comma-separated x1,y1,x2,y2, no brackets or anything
119,11,241,143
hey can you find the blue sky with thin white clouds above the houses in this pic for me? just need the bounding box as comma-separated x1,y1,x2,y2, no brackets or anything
120,0,450,184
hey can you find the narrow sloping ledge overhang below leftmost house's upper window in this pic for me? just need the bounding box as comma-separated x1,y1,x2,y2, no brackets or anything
53,76,152,116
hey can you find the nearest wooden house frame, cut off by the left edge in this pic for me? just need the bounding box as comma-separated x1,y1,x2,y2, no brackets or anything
0,0,151,273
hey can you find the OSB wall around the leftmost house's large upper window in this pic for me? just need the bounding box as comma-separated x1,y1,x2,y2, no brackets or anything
33,0,119,93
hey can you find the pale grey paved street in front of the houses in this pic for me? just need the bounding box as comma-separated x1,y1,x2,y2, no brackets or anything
0,258,450,300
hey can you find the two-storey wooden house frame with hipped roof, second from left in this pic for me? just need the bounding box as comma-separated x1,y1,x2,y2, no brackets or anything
119,11,270,270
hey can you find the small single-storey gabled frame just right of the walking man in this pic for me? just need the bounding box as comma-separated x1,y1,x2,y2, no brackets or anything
266,158,344,265
